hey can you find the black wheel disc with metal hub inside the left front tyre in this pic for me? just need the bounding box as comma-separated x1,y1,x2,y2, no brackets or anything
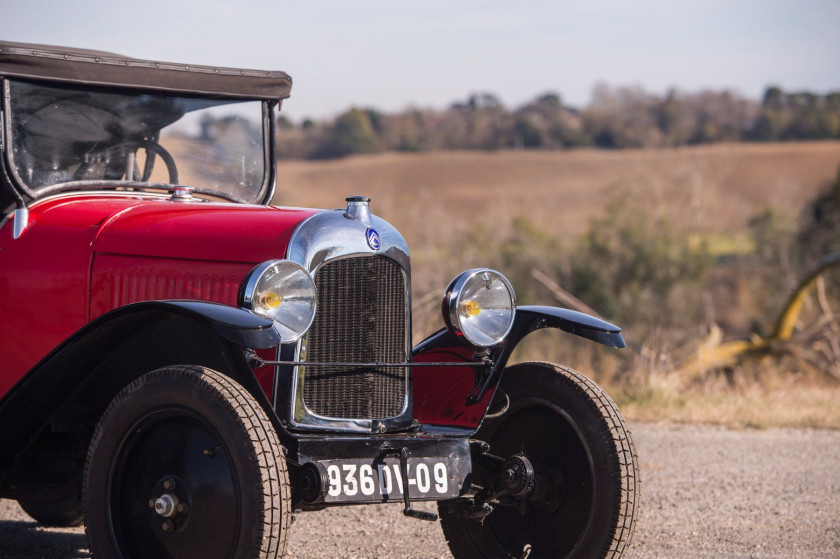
109,410,241,559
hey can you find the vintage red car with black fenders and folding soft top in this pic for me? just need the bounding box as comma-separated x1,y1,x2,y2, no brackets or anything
0,43,639,559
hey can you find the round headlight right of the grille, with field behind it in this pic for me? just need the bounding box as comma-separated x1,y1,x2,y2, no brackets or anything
443,268,516,347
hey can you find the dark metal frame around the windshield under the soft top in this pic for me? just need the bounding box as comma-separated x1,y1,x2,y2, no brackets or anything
0,76,279,205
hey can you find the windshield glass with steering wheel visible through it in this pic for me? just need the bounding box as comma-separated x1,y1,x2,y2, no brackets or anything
8,81,267,203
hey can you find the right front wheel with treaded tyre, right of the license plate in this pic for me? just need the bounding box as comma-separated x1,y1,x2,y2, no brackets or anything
438,363,640,559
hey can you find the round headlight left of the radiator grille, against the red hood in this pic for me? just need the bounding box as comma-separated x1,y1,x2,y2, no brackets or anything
239,260,315,342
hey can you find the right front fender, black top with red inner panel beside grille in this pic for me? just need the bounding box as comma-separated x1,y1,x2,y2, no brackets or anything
411,306,626,432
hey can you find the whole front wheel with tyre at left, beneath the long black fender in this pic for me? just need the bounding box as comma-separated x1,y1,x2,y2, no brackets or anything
84,365,291,559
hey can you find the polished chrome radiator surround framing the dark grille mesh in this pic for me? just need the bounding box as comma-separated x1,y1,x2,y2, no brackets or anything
286,209,414,433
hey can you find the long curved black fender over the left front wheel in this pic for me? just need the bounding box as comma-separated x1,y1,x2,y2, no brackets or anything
0,301,281,480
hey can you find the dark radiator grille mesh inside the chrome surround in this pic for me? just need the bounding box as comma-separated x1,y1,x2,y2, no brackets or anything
303,256,406,419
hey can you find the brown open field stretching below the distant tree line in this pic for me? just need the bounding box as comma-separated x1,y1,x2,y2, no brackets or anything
275,142,840,240
